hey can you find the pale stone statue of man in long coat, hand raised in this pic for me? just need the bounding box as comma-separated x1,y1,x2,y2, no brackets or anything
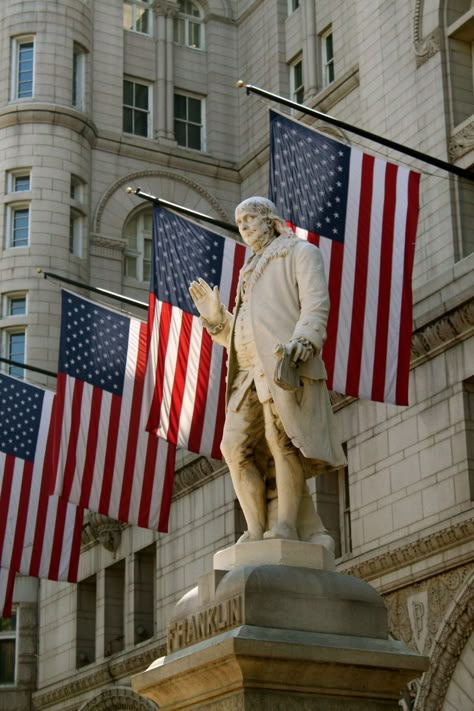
189,197,345,547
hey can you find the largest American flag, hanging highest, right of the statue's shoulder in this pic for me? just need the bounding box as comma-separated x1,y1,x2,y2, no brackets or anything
270,112,420,405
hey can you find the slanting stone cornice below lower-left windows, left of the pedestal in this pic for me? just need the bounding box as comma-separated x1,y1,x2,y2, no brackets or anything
32,640,166,711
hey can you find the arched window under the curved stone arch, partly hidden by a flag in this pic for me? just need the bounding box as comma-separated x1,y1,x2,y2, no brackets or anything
124,210,153,282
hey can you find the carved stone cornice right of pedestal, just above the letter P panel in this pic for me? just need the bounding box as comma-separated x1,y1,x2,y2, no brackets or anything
338,519,474,581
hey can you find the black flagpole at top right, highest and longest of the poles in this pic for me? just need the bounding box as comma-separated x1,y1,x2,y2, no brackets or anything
236,81,474,181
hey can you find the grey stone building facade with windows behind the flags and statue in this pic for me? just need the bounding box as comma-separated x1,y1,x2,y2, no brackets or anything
0,0,474,711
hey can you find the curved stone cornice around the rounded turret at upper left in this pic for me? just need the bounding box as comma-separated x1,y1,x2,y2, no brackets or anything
0,101,97,147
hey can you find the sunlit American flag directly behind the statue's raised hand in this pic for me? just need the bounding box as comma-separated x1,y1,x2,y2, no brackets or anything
147,206,246,459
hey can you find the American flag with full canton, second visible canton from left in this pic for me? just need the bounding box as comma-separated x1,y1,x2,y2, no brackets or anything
56,291,176,531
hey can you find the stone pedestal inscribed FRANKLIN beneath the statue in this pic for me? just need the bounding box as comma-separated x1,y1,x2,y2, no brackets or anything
132,541,427,711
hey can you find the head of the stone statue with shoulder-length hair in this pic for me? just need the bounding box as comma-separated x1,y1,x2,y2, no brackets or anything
235,197,288,251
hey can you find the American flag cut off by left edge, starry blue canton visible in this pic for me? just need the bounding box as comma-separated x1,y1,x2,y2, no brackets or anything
0,374,84,608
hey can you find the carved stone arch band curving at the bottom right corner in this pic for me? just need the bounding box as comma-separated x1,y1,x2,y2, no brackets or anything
414,571,474,711
